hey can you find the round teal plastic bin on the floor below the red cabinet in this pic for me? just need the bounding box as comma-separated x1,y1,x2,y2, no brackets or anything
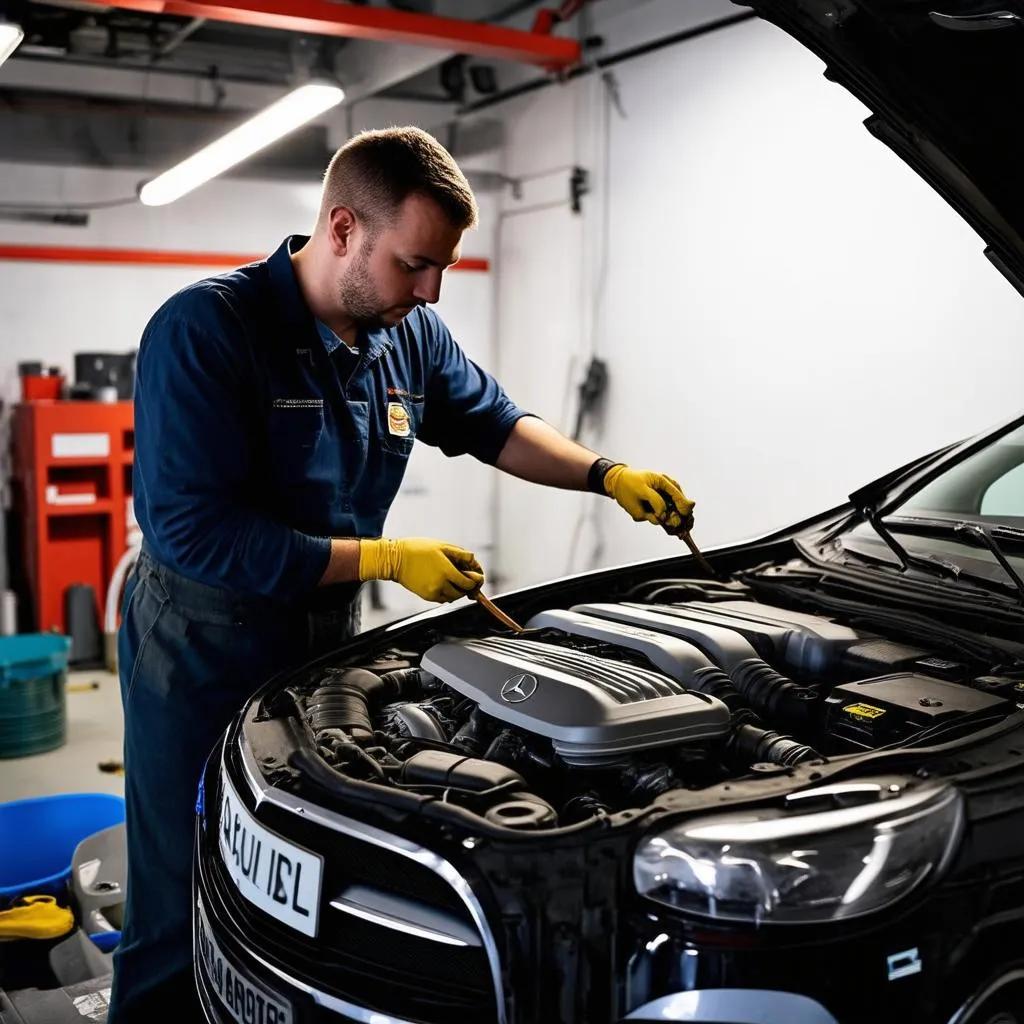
0,633,71,758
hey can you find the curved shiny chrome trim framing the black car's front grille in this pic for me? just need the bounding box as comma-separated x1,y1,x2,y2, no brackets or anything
239,732,507,1024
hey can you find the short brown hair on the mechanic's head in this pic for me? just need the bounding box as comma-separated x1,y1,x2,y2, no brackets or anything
321,127,477,232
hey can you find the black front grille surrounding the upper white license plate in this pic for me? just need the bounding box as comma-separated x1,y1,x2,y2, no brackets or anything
202,761,495,1024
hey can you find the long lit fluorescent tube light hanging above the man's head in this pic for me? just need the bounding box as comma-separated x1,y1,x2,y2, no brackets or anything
138,82,345,206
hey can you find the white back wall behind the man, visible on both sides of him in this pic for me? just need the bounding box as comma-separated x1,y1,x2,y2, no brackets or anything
0,145,495,611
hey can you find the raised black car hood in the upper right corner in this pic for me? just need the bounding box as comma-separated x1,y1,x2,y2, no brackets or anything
741,0,1024,295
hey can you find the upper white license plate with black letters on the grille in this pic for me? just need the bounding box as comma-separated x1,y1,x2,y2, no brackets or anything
217,765,324,936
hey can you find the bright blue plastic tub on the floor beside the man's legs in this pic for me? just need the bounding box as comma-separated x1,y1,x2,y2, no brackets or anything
0,793,125,900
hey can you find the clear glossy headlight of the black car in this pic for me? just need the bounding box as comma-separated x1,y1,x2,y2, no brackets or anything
633,782,964,924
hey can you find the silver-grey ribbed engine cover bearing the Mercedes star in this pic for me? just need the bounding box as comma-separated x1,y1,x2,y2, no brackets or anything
422,637,729,767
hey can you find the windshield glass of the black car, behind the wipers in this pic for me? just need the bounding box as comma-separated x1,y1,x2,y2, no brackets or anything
894,427,1024,527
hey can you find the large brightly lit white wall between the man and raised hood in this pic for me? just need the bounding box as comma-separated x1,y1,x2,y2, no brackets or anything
487,0,1024,586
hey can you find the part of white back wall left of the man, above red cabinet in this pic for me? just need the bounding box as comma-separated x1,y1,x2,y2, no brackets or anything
0,164,318,400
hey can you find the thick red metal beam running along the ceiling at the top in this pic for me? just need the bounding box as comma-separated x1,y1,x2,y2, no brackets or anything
91,0,581,71
